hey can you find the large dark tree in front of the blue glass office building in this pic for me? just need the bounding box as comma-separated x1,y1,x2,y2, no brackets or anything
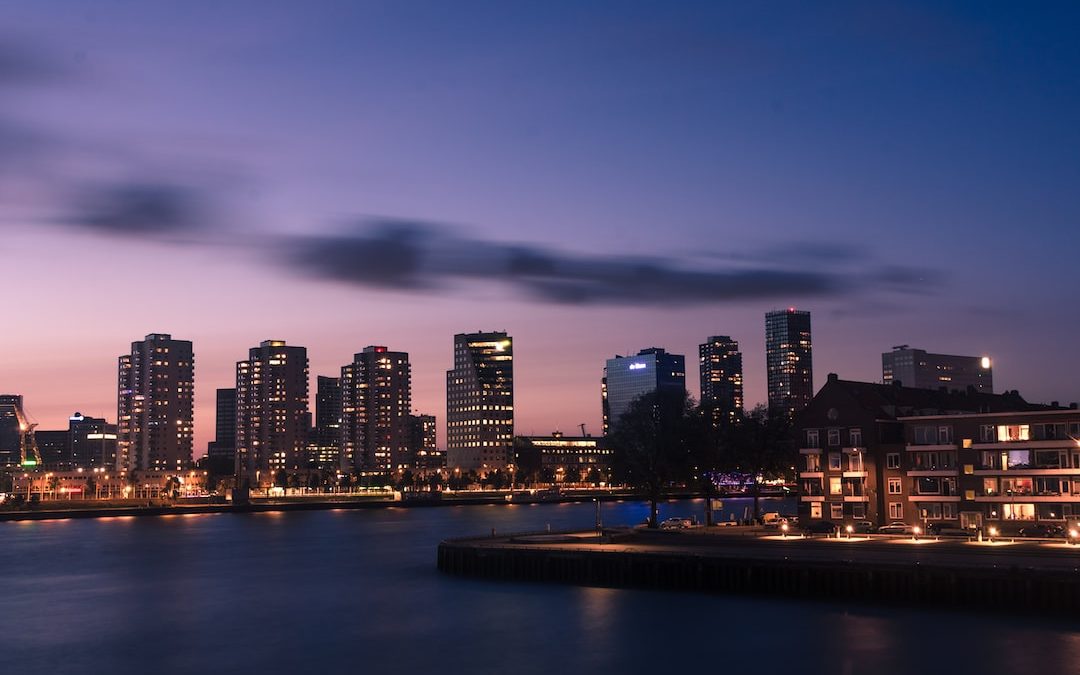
609,392,696,527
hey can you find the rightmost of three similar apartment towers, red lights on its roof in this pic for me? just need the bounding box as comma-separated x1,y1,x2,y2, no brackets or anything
341,346,413,473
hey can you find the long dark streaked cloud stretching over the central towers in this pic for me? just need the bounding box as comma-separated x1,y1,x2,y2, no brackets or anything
280,220,937,306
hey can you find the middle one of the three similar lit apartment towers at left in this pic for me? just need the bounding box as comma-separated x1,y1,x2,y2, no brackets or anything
237,340,310,486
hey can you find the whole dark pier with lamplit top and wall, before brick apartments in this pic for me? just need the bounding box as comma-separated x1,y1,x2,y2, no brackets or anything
438,528,1080,616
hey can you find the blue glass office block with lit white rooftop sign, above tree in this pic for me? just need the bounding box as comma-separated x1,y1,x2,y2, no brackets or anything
600,347,686,435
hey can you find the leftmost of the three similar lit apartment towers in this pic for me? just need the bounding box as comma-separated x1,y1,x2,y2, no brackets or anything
117,333,194,471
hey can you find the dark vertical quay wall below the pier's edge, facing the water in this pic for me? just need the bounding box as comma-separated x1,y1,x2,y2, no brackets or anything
437,541,1080,617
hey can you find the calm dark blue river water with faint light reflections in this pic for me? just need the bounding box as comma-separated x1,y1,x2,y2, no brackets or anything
0,500,1080,675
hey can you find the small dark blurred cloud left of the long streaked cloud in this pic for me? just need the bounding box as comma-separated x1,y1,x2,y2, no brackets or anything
65,183,210,239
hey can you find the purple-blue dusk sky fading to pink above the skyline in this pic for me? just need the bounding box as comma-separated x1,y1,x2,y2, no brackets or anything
0,0,1080,457
